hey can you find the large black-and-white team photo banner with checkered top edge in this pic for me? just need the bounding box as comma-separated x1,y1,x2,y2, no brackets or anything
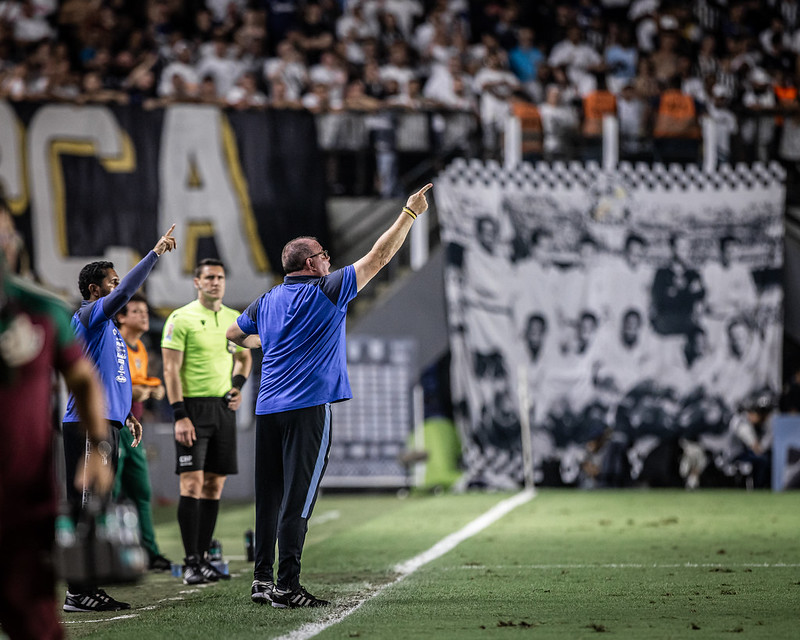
435,160,784,487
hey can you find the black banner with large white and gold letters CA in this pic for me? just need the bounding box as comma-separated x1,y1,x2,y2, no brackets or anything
0,101,328,309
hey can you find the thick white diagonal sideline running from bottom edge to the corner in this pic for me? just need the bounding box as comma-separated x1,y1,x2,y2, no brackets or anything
276,489,536,640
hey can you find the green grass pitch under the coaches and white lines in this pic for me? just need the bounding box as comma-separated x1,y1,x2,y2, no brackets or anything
59,489,800,640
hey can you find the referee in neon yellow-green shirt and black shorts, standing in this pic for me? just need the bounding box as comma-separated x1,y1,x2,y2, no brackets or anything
161,258,252,584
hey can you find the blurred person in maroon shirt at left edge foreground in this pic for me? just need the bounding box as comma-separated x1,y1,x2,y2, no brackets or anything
0,251,113,640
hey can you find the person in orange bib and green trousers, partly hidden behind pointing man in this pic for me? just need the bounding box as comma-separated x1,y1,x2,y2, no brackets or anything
114,293,172,571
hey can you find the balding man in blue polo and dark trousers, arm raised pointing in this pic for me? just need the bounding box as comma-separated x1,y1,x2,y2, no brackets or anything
227,184,433,608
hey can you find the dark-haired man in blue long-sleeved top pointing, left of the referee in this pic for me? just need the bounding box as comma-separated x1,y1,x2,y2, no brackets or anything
63,225,175,612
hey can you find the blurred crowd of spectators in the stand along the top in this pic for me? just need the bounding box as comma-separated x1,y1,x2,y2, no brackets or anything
0,0,800,165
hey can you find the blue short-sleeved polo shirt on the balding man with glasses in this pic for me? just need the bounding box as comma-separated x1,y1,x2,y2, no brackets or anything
236,265,358,415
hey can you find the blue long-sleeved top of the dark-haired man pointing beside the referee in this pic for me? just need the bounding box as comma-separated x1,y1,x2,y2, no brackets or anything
64,251,158,425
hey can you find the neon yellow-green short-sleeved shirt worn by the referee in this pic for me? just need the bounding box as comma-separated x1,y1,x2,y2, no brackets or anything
161,300,242,398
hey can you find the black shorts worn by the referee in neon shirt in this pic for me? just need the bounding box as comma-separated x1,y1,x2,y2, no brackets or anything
175,398,239,476
